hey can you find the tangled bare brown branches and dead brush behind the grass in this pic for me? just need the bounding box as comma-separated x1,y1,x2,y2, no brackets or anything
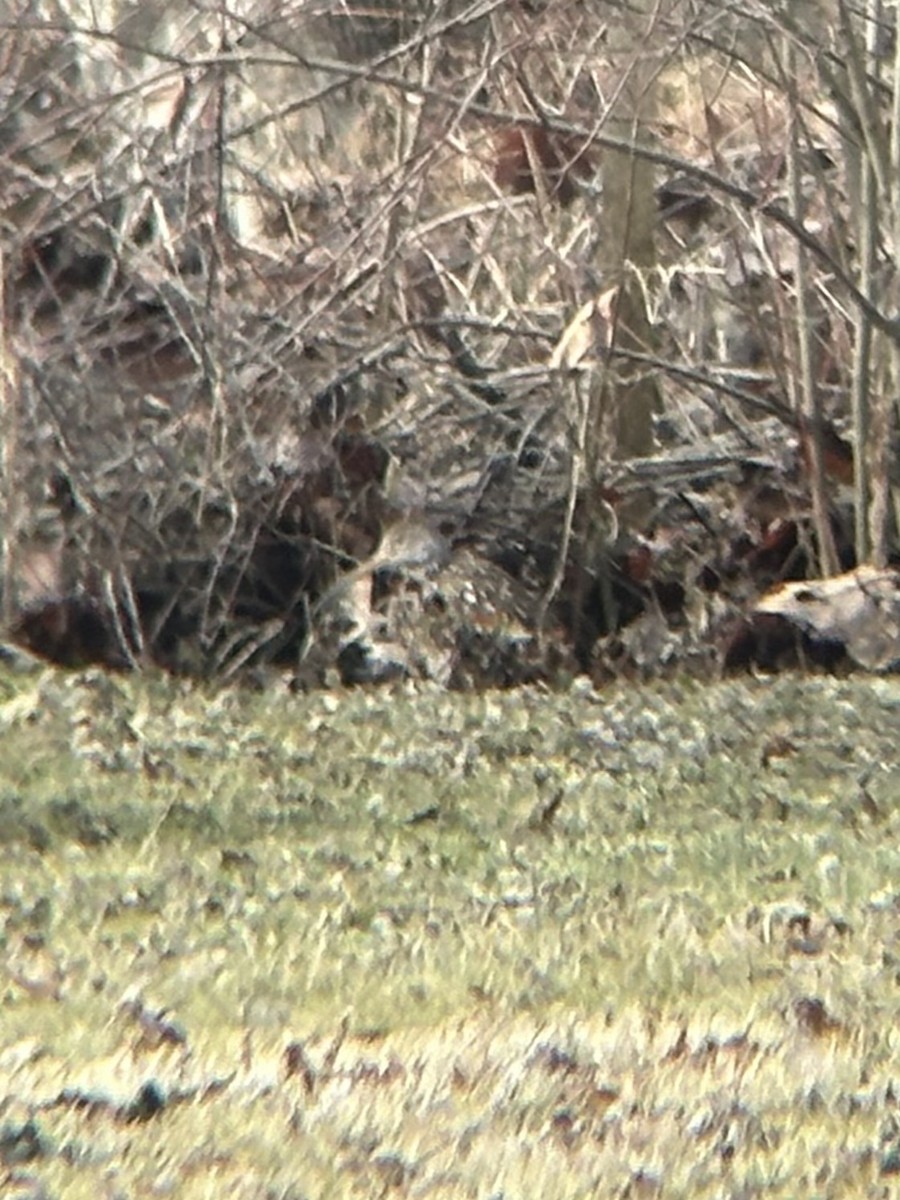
0,0,898,683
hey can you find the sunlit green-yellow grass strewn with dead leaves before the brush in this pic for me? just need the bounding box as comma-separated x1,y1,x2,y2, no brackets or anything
0,670,900,1200
